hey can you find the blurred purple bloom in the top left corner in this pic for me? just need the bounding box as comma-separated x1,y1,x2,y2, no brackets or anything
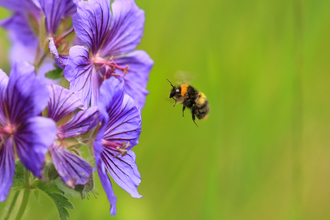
0,0,79,62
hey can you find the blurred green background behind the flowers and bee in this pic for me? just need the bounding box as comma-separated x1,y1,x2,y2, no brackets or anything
0,0,330,220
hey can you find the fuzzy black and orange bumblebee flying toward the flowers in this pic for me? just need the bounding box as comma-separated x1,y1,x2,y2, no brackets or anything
167,79,210,127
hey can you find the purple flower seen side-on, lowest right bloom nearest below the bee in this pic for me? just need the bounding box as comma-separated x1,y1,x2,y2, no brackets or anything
94,77,142,215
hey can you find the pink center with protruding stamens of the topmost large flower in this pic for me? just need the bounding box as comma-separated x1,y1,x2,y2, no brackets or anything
93,56,129,80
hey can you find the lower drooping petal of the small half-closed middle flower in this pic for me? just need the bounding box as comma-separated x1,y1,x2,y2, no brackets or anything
49,143,93,188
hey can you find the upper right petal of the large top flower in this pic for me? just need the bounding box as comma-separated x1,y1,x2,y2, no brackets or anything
100,0,145,57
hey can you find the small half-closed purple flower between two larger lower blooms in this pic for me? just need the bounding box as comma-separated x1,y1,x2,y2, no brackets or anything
47,85,98,188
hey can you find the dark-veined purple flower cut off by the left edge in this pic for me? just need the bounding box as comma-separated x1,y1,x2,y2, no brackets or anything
0,62,56,202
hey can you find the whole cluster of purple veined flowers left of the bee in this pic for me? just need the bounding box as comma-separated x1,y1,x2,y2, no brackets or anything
0,0,153,215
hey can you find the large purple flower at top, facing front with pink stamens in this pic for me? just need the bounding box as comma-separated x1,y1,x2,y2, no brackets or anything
64,0,153,110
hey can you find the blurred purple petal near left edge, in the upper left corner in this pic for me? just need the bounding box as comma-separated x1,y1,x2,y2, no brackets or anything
0,12,37,46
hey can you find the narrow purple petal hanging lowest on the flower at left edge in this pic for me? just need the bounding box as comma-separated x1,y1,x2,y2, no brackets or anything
0,138,15,202
